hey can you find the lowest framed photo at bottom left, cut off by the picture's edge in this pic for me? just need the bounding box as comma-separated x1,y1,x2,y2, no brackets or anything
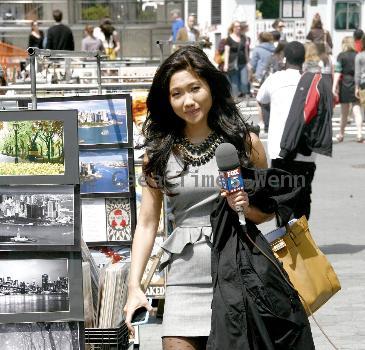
0,322,84,350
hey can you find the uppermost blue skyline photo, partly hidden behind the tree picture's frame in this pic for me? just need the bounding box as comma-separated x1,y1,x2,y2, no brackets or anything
38,98,128,145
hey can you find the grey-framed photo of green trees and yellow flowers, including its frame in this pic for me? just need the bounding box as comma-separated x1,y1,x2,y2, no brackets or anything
0,110,79,185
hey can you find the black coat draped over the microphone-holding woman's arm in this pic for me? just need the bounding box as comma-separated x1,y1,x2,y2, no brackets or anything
207,169,314,350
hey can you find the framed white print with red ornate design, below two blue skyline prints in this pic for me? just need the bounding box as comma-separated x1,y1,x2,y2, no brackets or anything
81,198,136,245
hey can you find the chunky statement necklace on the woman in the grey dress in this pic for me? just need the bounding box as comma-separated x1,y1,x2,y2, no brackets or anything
175,131,224,166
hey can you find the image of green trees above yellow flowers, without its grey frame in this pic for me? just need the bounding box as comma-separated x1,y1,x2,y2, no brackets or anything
0,120,65,176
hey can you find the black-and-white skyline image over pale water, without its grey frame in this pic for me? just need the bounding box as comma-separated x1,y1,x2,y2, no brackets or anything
0,258,70,314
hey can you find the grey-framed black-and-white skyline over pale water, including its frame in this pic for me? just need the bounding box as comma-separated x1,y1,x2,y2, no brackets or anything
0,252,84,323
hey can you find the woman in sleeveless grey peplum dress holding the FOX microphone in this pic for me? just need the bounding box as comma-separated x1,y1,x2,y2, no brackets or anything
124,46,312,350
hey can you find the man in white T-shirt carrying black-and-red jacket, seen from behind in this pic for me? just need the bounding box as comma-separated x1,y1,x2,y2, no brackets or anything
256,41,333,219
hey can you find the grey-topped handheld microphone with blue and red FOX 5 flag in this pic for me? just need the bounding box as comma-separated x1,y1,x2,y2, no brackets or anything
215,143,246,229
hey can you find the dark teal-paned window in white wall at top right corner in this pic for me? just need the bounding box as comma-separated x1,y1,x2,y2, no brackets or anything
335,1,361,30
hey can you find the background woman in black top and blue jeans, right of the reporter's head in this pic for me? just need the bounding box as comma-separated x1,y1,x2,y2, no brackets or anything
223,21,250,97
